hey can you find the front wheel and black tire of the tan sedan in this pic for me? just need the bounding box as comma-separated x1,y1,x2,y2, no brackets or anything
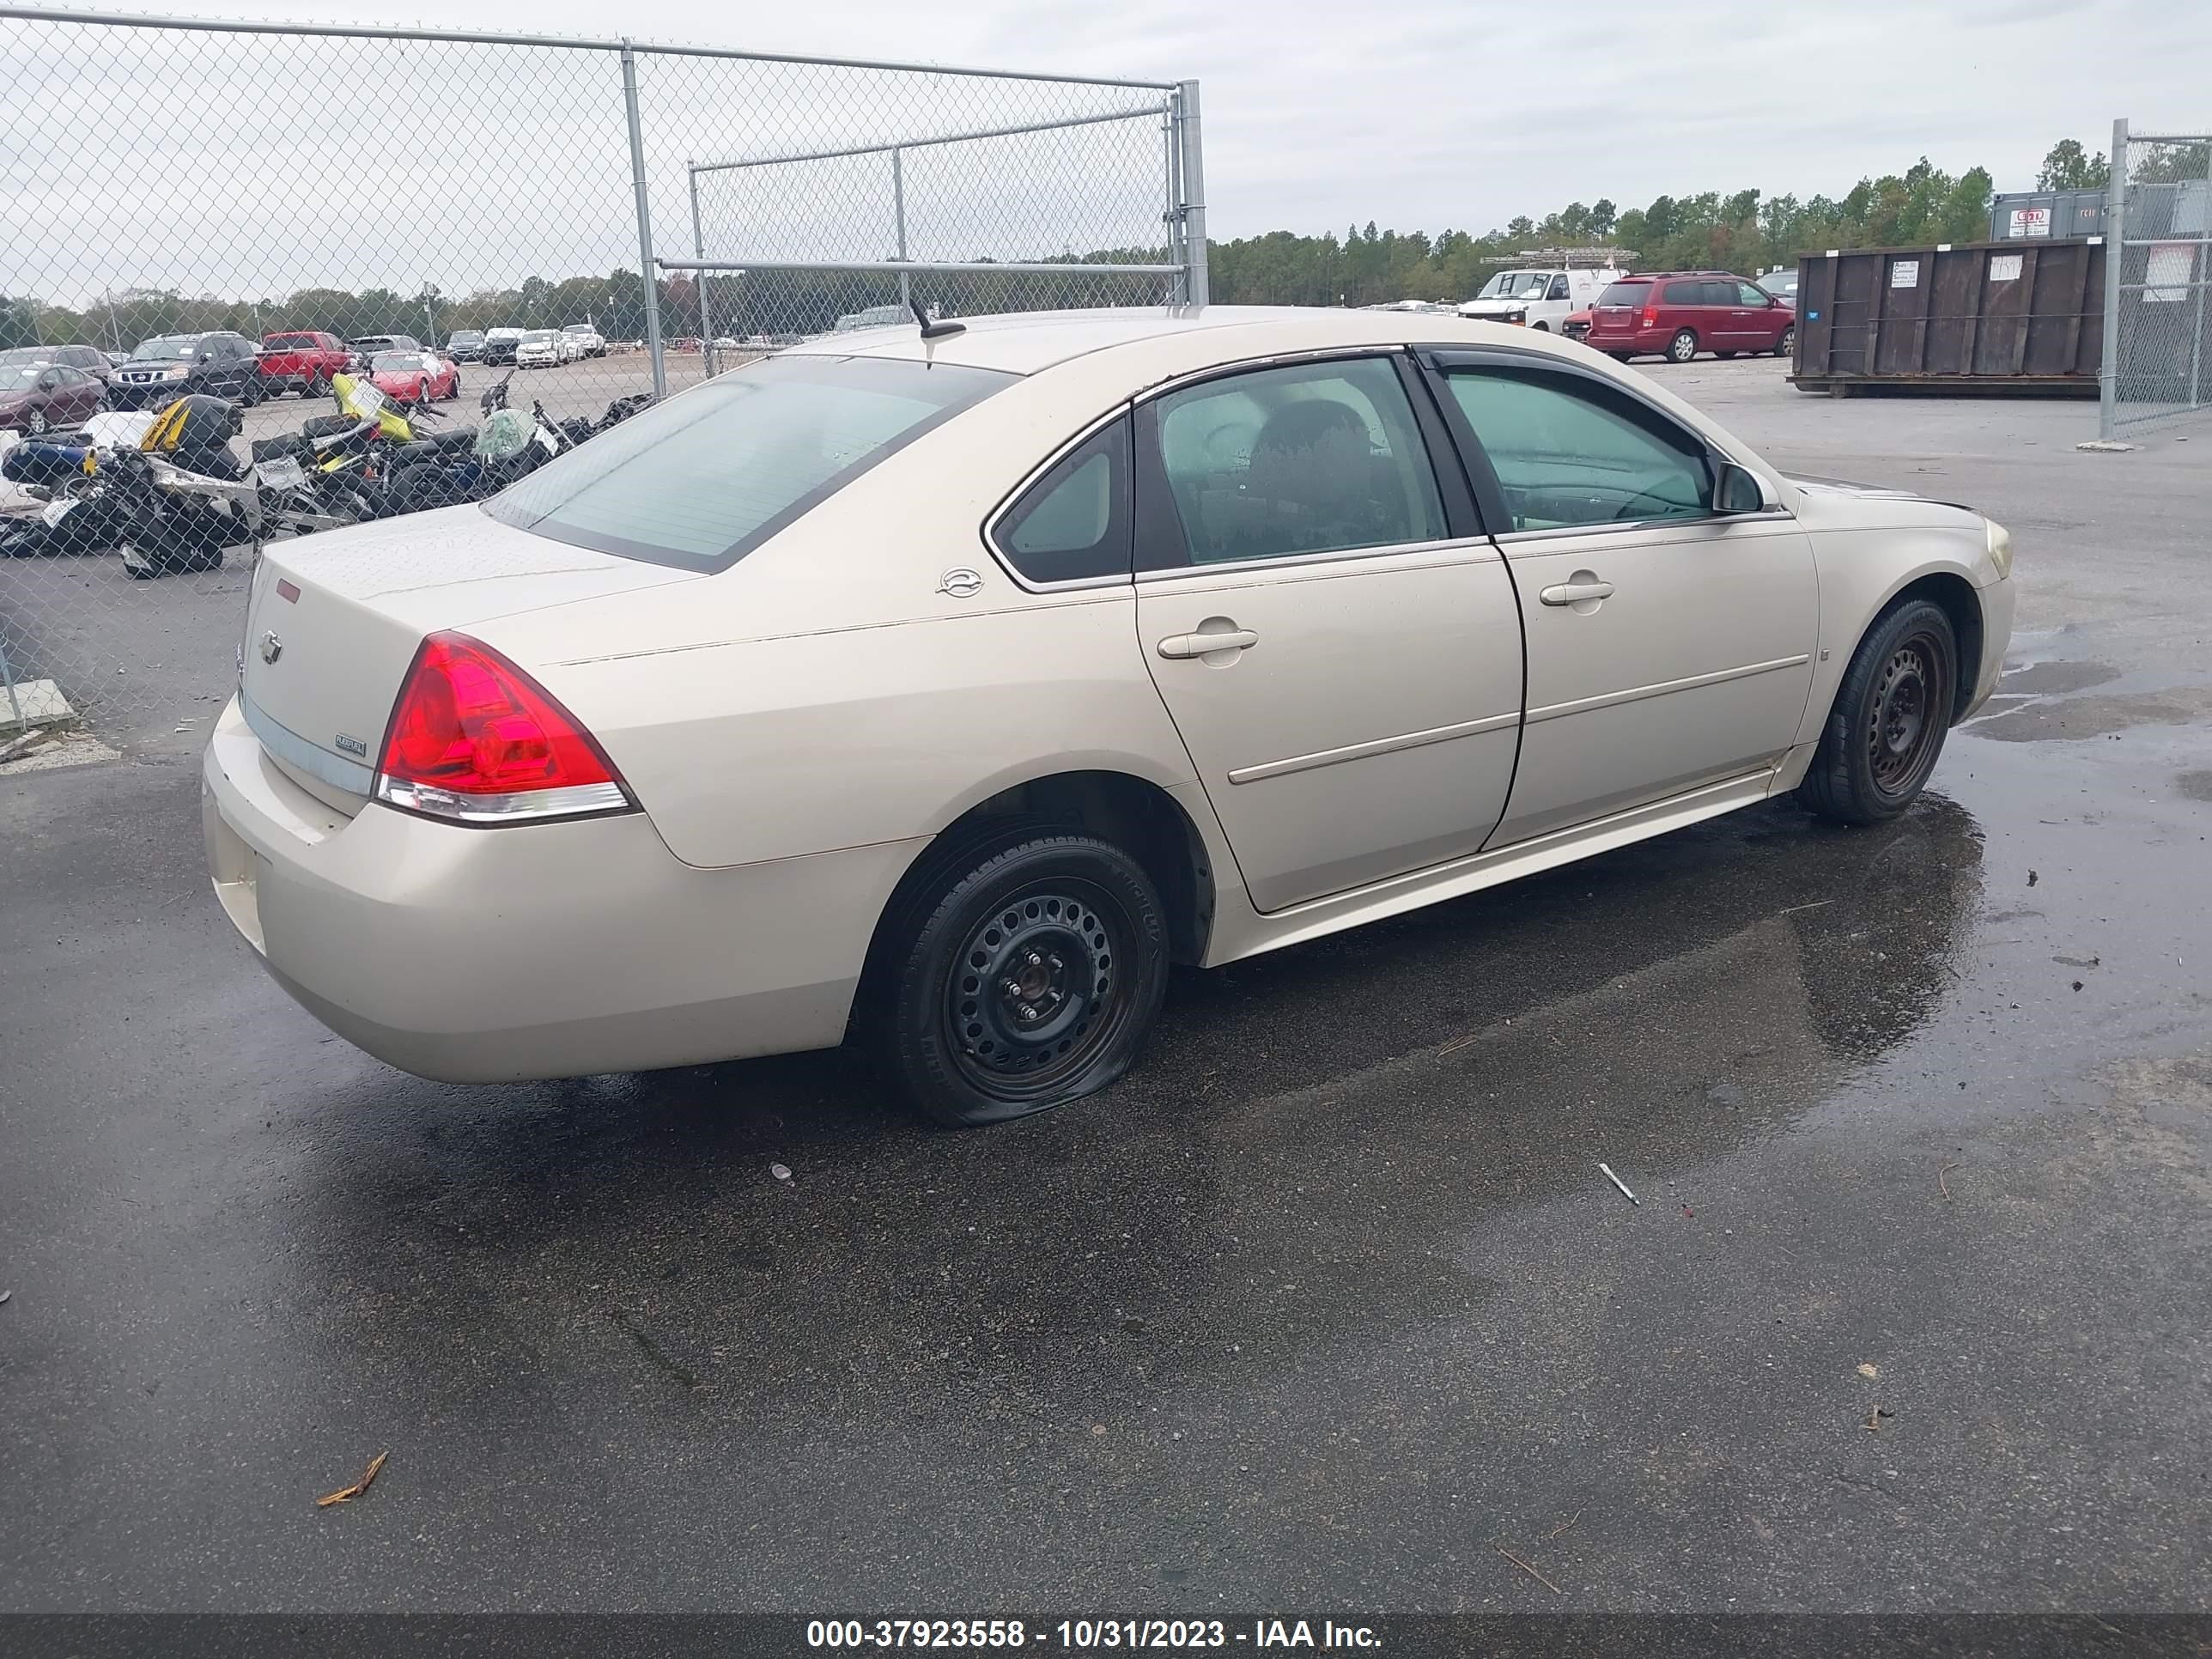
1796,599,1958,823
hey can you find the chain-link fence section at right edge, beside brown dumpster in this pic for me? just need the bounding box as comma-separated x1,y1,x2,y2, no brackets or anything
2097,122,2212,441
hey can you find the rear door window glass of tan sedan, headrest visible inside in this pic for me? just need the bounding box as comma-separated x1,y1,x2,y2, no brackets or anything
1151,356,1447,564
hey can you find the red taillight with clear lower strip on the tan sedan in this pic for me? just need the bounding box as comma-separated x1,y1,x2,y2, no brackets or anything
376,633,635,823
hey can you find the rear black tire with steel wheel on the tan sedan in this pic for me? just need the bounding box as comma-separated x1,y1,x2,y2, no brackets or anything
872,827,1168,1128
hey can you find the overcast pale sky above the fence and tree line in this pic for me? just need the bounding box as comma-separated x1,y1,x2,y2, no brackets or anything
143,0,2212,237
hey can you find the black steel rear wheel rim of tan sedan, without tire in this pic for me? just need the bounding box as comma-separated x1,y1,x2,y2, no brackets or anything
945,878,1130,1103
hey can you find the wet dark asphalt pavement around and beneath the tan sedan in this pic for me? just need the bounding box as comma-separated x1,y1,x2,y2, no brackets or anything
0,362,2212,1617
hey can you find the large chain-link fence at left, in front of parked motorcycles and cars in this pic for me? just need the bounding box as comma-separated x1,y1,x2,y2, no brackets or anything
0,7,1206,738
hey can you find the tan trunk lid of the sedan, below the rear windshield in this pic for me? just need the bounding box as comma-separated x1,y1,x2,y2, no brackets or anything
239,507,699,811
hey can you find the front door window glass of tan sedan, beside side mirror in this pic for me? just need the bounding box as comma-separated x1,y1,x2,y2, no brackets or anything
1447,368,1712,531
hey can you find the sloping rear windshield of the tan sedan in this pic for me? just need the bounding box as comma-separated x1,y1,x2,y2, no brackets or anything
484,356,1015,571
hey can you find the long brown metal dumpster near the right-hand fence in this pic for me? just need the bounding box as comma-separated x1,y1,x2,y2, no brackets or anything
1790,237,2104,398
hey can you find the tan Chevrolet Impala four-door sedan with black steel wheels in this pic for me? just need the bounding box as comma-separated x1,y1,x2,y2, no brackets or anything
206,307,2013,1124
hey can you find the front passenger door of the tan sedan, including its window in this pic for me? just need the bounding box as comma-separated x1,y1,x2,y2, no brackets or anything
1433,352,1818,845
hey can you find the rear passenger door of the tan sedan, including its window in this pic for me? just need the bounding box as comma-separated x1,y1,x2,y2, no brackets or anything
1137,356,1522,911
